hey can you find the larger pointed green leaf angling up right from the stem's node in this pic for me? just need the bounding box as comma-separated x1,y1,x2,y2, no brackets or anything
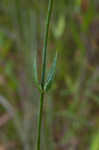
44,52,57,91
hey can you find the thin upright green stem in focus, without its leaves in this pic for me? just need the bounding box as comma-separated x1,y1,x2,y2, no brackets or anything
37,0,53,150
